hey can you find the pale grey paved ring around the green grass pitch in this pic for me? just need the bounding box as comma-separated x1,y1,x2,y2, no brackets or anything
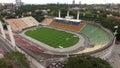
21,27,85,55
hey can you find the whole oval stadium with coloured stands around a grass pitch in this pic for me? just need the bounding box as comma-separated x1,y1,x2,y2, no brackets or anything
5,13,115,68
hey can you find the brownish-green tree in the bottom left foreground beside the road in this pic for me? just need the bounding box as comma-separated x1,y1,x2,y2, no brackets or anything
6,51,30,68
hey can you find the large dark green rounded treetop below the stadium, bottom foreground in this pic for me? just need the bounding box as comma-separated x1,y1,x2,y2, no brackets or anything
64,54,112,68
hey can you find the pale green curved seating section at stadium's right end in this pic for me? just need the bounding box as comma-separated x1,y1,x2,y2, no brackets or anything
80,24,110,45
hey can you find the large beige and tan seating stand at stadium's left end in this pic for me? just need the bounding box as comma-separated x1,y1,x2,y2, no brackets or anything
5,16,39,32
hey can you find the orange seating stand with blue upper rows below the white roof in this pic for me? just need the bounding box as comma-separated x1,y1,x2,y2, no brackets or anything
50,20,84,32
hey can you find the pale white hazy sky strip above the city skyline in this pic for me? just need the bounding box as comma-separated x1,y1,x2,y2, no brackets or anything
0,0,120,4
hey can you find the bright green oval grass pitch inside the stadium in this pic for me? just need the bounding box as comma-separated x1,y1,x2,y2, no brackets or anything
25,27,79,48
